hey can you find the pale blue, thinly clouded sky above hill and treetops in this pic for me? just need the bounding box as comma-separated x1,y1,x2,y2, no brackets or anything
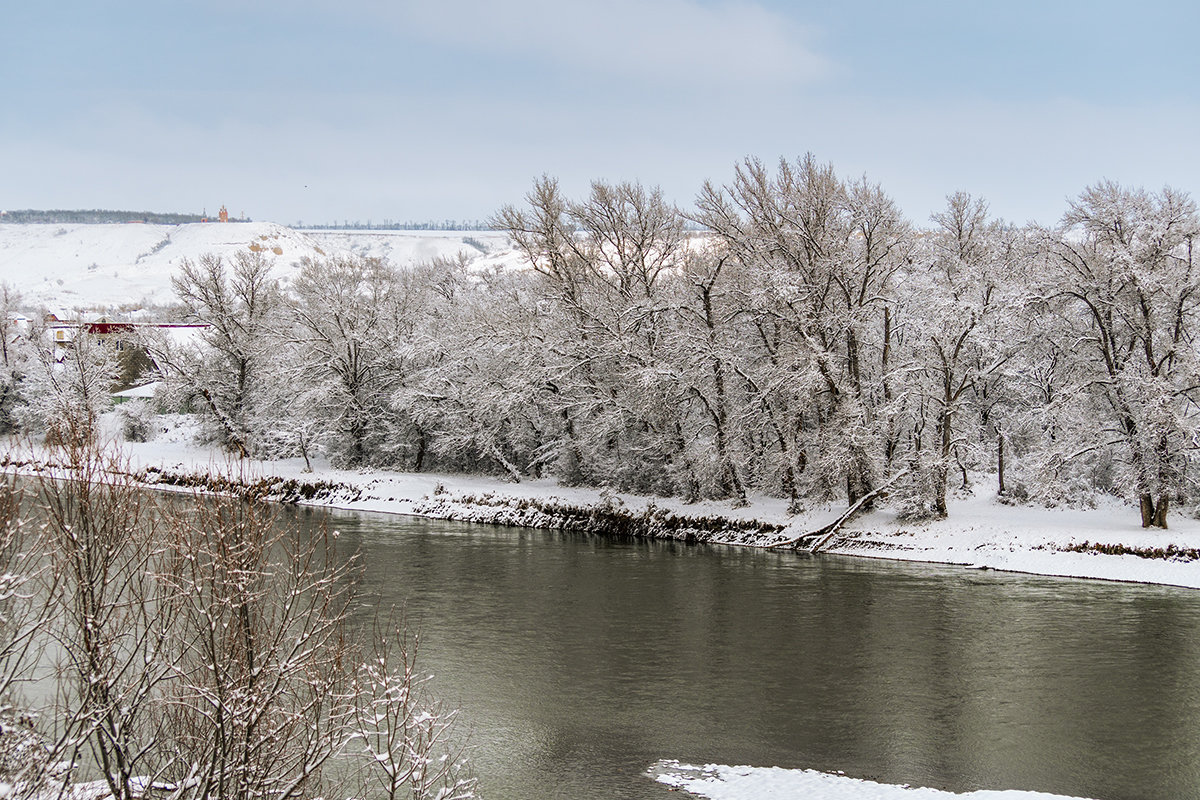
0,0,1200,224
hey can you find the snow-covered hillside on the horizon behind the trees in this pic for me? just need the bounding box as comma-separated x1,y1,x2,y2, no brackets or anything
0,222,517,309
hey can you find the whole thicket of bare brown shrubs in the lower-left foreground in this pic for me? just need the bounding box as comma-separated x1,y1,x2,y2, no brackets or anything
0,437,476,800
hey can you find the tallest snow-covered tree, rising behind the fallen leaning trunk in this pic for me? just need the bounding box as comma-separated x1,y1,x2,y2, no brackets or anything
696,155,912,504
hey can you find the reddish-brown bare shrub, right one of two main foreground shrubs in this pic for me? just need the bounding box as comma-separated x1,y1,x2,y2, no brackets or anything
154,497,353,800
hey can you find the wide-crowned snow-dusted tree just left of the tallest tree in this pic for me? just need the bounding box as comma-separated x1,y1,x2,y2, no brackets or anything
494,179,686,492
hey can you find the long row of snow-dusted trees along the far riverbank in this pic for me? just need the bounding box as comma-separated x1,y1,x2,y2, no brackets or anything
9,156,1200,527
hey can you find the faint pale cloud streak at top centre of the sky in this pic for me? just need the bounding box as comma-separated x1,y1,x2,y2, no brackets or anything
400,0,828,86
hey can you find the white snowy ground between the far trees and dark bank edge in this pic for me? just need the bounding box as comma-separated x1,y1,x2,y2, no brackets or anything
49,416,1200,589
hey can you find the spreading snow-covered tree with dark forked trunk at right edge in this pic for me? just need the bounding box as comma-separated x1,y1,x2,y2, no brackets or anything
1044,181,1200,528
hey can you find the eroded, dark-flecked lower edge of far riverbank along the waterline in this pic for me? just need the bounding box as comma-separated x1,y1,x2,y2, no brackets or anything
9,456,1200,589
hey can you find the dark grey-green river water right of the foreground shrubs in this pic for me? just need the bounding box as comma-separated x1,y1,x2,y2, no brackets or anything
298,511,1200,800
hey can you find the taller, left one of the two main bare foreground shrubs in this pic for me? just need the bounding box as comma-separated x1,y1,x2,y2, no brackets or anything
37,439,170,800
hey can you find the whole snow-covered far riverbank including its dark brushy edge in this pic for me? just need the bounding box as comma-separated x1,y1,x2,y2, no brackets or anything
23,412,1200,588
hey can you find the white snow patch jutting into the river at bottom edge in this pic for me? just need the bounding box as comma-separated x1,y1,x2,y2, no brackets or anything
648,760,1099,800
